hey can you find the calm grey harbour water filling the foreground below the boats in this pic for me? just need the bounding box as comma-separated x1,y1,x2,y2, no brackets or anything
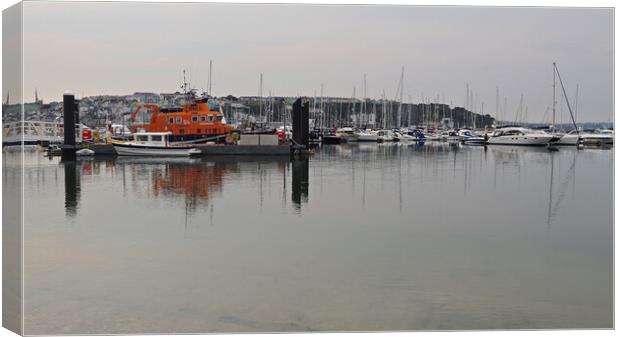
9,144,614,334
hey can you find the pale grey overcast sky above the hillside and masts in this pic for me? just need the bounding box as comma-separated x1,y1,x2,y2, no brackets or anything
15,2,613,122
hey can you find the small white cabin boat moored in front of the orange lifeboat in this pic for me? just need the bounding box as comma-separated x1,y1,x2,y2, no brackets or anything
112,132,201,157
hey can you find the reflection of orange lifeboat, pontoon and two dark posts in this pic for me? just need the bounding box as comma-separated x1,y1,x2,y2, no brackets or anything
61,156,309,216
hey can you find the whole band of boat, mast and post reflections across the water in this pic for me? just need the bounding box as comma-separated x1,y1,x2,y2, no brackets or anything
61,143,604,226
